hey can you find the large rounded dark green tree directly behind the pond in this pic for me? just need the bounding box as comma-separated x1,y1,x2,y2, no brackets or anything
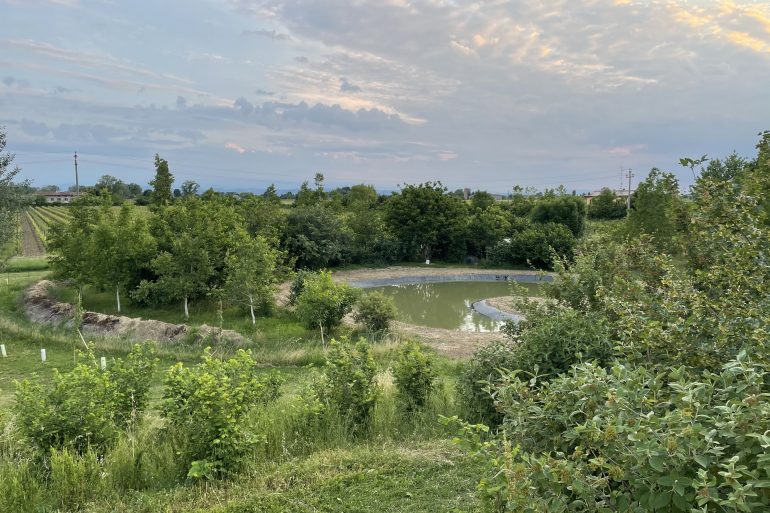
385,182,467,260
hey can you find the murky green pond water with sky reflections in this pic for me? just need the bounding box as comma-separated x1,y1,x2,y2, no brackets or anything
367,281,540,331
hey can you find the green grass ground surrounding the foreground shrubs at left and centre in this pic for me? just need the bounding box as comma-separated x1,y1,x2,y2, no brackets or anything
0,258,481,513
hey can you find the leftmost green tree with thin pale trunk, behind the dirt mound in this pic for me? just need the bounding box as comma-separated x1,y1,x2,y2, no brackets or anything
92,204,156,313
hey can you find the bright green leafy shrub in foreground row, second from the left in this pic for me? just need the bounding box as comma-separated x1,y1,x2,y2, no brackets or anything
162,348,282,478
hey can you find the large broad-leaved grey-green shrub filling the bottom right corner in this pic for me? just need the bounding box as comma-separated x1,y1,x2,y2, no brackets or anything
452,355,770,513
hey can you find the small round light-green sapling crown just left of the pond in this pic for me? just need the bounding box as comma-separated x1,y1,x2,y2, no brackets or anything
297,271,359,331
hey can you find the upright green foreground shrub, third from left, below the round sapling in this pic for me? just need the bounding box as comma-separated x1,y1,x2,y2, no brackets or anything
317,339,379,431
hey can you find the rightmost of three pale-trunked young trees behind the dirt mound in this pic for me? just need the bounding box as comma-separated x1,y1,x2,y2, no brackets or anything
225,236,278,325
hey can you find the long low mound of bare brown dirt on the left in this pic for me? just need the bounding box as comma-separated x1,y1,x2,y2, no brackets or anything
24,280,247,345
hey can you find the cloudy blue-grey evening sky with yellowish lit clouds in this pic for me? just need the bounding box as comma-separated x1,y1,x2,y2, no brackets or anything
0,0,770,193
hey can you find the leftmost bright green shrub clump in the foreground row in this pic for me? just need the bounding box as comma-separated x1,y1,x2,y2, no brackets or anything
15,345,156,453
